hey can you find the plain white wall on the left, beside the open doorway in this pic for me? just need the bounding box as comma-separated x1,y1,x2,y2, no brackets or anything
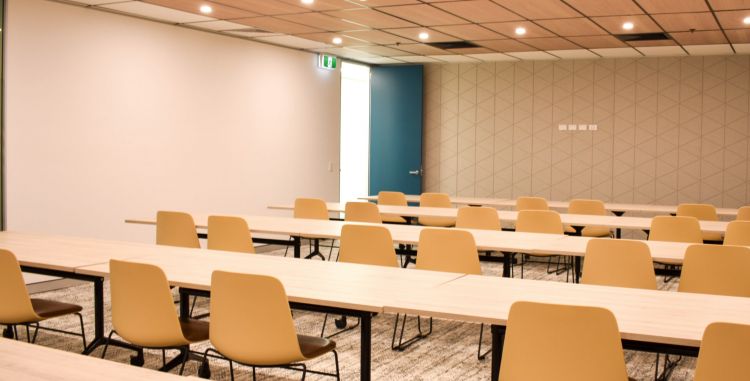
4,0,340,241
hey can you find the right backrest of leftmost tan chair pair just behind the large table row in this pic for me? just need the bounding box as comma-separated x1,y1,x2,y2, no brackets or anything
207,216,255,253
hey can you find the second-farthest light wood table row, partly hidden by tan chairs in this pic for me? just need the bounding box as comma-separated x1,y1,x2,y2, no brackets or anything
269,202,728,234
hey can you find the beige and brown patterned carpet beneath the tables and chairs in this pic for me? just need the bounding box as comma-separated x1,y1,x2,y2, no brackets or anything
11,246,695,380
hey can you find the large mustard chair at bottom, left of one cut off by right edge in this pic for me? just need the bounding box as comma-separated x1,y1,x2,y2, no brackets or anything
500,302,628,381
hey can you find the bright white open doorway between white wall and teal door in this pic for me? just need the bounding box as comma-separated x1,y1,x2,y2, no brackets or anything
339,62,370,202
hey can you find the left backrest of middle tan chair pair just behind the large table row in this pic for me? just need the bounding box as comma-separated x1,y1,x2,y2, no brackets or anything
339,225,398,267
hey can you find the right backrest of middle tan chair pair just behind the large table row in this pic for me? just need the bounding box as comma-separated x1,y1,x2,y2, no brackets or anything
417,229,482,275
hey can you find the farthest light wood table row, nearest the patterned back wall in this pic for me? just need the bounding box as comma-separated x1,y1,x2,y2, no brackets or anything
361,195,738,217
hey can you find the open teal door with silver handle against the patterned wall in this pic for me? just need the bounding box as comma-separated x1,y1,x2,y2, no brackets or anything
369,65,423,195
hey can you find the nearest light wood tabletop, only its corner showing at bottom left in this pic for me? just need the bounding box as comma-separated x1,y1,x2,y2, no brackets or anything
0,339,199,381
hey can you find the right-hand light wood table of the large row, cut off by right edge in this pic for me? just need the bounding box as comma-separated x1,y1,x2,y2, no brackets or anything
385,275,750,380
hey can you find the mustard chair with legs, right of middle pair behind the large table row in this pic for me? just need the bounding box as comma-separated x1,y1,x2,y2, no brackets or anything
391,228,482,351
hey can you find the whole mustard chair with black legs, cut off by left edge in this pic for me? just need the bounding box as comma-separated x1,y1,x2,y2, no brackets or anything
0,249,86,351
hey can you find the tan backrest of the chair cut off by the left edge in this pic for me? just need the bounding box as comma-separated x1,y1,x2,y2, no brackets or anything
0,249,42,324
